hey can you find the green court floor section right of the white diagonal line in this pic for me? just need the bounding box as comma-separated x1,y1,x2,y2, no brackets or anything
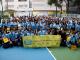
49,47,80,60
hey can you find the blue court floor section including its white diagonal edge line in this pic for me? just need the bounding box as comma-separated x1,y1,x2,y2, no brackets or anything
0,47,56,60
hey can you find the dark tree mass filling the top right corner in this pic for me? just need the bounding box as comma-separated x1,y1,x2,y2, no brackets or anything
65,0,80,13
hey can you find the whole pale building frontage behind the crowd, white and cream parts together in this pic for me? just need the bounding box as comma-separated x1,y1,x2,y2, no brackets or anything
0,0,66,16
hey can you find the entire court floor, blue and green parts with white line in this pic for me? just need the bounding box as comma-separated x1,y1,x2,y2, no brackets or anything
0,47,80,60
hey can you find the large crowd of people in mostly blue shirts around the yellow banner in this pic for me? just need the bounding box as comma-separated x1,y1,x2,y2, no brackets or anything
0,16,80,48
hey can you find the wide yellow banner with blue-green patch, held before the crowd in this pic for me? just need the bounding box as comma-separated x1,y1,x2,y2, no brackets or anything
23,35,61,48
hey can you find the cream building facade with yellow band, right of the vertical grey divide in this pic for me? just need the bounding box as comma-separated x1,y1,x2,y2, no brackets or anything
32,0,66,15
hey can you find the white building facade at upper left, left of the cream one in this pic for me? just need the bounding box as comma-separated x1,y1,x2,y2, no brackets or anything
0,0,32,16
